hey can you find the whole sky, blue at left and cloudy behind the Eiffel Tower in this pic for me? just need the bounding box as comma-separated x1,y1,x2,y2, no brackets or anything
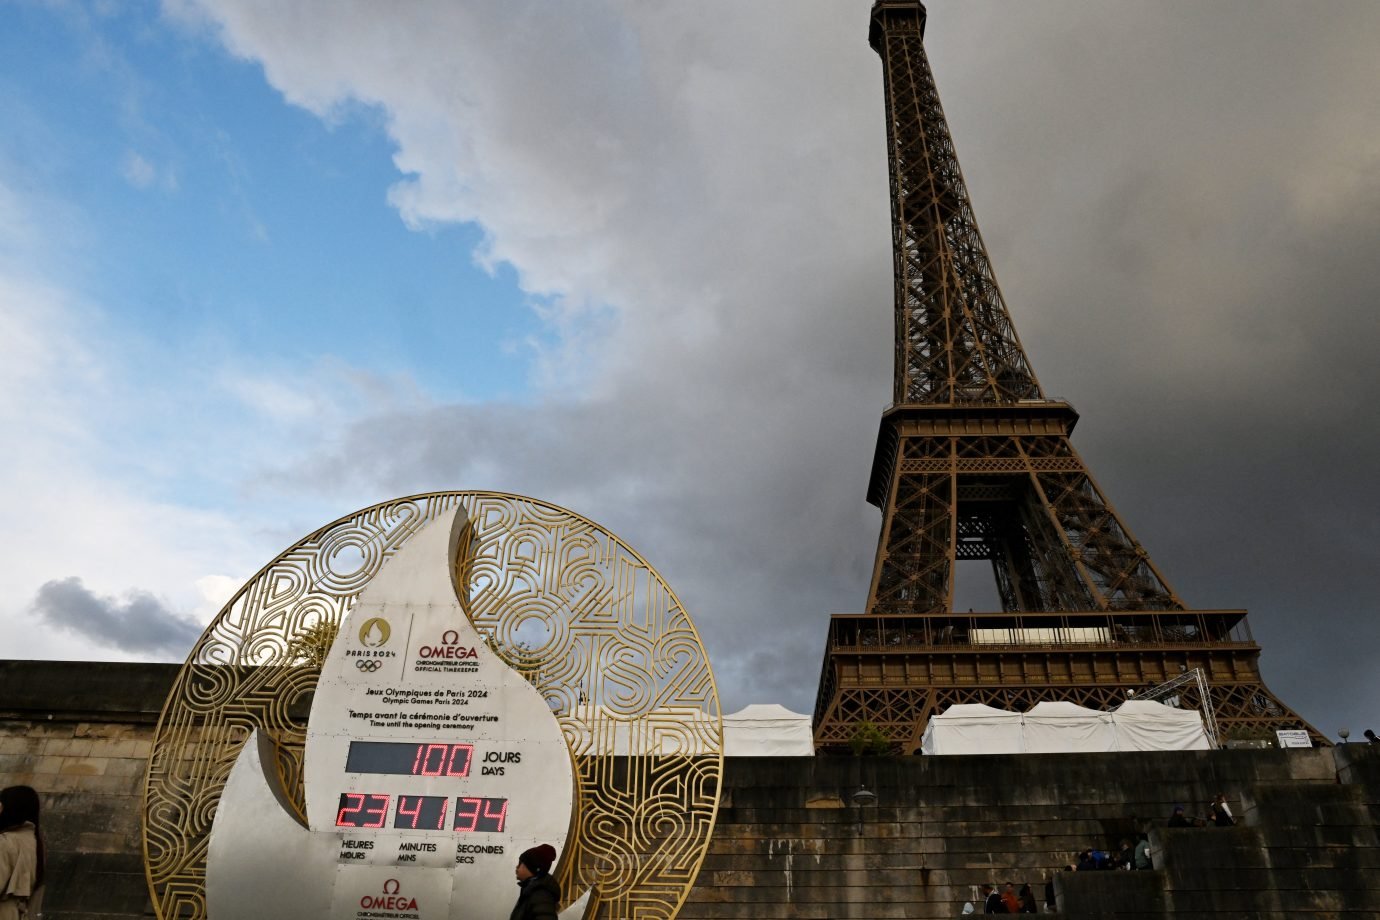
0,0,1380,737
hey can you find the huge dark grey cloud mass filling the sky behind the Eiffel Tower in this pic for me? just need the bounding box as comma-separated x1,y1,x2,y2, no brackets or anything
186,0,1380,732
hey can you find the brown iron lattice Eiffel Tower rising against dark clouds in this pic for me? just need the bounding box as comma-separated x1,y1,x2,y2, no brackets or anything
814,0,1328,753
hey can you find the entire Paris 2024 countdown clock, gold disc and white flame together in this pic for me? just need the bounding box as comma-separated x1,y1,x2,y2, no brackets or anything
145,492,722,920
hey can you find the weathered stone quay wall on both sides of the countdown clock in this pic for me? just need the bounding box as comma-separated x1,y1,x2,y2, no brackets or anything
0,662,1380,920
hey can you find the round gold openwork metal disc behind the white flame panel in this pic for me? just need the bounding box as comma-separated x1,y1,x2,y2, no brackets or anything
144,492,723,920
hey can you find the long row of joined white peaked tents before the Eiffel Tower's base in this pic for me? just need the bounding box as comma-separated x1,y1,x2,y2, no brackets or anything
920,699,1213,754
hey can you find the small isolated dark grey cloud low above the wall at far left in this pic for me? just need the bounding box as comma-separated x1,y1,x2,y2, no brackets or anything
33,577,201,655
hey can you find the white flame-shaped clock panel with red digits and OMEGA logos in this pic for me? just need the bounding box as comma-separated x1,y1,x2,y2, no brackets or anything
207,512,578,920
